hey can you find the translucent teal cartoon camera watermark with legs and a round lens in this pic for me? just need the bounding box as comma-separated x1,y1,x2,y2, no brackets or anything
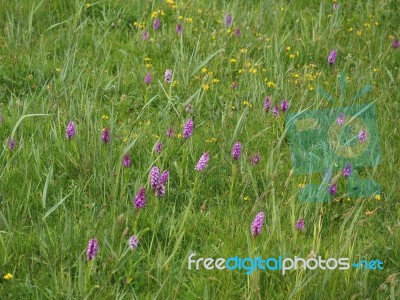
286,74,381,202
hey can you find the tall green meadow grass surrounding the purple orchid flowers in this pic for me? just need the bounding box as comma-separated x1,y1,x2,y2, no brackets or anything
0,0,400,299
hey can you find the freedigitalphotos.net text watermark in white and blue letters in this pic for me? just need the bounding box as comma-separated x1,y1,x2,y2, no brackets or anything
188,253,383,275
